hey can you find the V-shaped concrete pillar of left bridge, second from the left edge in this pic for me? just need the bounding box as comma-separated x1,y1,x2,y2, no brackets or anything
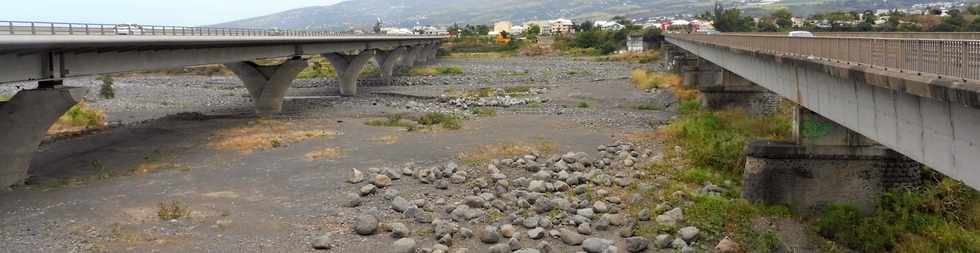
225,58,308,116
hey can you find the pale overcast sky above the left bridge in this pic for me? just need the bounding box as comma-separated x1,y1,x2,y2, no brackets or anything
0,0,344,26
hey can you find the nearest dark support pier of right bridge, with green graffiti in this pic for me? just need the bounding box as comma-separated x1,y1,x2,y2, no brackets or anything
742,108,920,214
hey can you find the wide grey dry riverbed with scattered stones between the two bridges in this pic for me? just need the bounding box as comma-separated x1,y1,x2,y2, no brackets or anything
0,54,688,253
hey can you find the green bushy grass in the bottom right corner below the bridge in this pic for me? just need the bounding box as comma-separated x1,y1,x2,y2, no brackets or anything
814,175,980,252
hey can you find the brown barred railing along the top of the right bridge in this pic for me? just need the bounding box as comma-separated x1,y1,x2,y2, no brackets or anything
667,34,980,80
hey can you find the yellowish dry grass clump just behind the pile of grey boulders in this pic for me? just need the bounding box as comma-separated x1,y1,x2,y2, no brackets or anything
456,140,558,166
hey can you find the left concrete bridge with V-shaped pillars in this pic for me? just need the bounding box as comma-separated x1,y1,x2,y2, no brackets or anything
0,21,444,188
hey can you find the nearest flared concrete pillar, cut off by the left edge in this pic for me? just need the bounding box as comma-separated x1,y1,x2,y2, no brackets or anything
0,86,88,189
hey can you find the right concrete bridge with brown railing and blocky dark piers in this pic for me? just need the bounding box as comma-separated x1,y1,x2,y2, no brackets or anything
666,33,980,211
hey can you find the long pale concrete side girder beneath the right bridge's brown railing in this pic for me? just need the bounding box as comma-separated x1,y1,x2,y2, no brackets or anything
668,38,980,188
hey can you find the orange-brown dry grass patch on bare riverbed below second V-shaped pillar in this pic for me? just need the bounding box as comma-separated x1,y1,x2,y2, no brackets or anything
208,119,336,154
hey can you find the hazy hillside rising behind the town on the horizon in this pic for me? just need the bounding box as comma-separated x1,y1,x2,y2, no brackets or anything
215,0,960,31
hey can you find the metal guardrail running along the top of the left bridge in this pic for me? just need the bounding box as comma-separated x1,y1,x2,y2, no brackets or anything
0,21,428,37
